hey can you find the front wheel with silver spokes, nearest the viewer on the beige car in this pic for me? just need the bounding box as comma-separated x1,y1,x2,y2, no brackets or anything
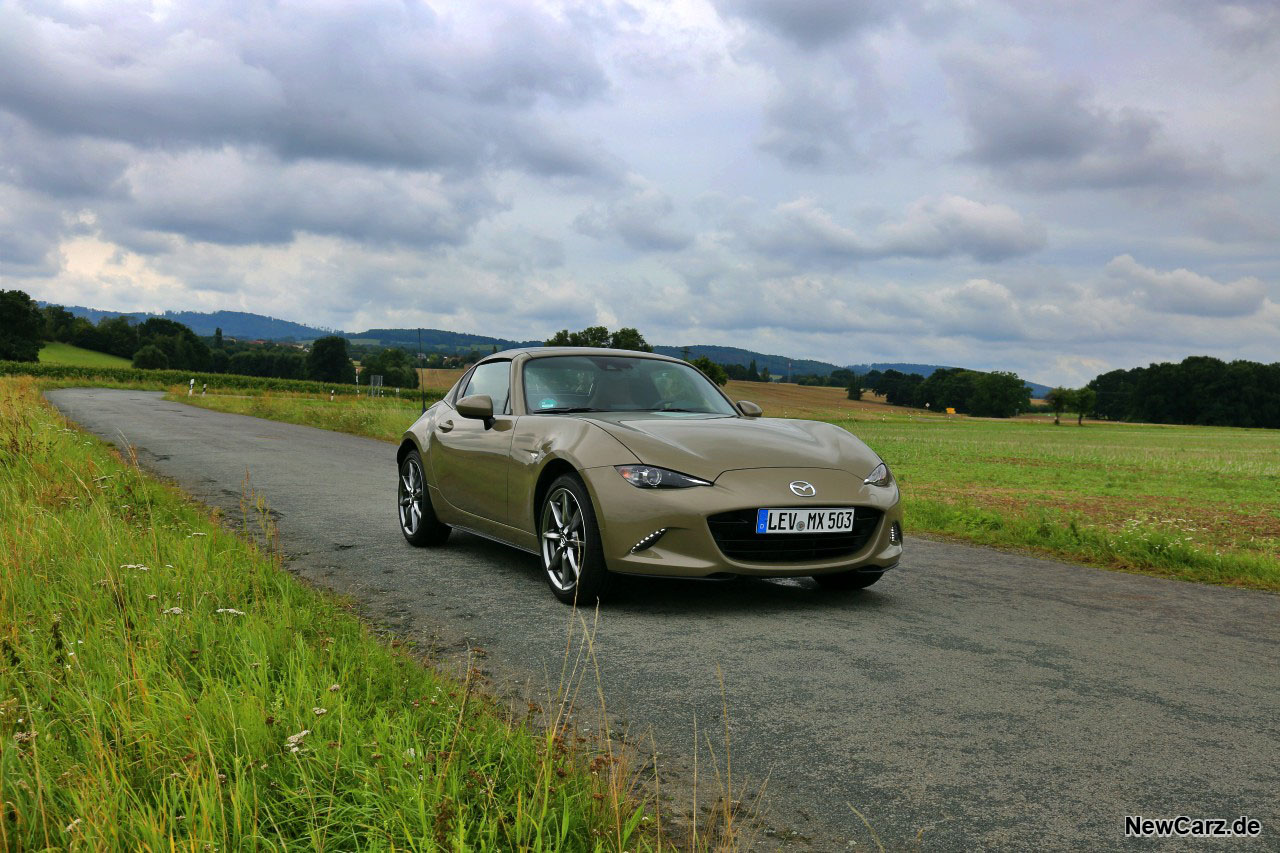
538,474,609,606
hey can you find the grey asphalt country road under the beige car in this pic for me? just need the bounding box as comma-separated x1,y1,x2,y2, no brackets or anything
49,389,1280,850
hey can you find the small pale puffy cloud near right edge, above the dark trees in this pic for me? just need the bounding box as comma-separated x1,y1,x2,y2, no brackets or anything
1106,255,1267,318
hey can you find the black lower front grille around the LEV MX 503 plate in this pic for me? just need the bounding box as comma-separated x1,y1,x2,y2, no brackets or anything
707,506,884,562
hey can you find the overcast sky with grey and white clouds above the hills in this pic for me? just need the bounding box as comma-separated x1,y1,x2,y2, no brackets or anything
0,0,1280,386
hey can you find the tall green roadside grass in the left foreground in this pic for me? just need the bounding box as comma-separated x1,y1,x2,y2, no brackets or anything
0,378,648,850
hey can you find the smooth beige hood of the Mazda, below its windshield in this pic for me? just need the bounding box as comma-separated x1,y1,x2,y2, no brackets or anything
591,412,879,480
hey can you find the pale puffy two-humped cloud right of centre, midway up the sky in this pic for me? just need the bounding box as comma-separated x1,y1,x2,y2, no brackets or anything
749,195,1046,264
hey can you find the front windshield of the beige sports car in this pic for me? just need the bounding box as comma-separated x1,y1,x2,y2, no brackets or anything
525,355,736,415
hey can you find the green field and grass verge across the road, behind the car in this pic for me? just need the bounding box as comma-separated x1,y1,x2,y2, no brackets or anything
170,383,1280,590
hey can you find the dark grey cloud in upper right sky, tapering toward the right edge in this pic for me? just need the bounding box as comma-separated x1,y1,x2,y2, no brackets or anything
945,49,1233,190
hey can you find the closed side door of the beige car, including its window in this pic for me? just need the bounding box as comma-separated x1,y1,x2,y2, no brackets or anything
430,360,516,524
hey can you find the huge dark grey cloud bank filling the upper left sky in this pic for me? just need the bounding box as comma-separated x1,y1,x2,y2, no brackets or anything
0,1,608,174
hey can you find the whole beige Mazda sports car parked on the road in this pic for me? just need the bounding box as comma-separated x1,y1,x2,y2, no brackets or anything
396,347,902,602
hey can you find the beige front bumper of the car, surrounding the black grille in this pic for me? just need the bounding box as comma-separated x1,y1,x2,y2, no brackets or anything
582,467,902,578
